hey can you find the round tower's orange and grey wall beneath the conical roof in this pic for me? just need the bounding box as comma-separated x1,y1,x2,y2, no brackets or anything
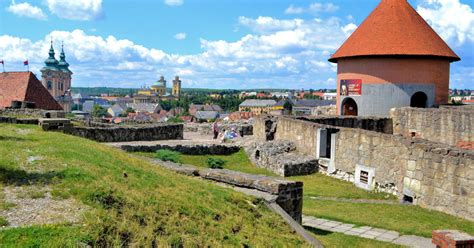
337,57,450,116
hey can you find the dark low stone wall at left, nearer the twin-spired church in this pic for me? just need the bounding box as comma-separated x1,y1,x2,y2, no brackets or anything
65,124,183,142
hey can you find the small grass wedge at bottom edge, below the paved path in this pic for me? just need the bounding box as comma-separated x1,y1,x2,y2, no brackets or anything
306,228,402,248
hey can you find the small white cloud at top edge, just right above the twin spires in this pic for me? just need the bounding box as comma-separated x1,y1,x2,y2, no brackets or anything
46,0,103,21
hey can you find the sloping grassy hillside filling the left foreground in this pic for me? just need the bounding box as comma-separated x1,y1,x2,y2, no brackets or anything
0,124,304,247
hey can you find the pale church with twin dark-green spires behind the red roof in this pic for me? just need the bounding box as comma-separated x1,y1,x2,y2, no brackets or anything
41,41,73,112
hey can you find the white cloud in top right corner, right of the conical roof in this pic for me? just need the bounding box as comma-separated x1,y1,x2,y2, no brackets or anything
417,0,474,46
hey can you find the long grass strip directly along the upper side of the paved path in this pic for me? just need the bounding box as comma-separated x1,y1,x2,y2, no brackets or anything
303,198,474,237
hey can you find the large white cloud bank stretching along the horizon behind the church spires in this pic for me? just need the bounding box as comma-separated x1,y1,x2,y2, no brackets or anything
0,17,358,88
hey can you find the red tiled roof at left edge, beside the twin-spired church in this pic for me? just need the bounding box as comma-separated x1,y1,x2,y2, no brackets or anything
0,72,63,110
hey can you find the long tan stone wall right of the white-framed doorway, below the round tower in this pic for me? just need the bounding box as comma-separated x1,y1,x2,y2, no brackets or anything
335,129,474,219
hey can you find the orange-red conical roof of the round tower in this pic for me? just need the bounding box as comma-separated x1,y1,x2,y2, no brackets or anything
329,0,461,62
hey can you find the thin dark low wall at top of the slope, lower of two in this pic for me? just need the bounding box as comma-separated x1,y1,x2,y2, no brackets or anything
120,144,240,155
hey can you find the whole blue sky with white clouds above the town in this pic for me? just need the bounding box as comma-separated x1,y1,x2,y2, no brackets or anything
0,0,474,89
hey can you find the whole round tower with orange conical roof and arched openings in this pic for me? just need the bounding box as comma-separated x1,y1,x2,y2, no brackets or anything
329,0,460,117
